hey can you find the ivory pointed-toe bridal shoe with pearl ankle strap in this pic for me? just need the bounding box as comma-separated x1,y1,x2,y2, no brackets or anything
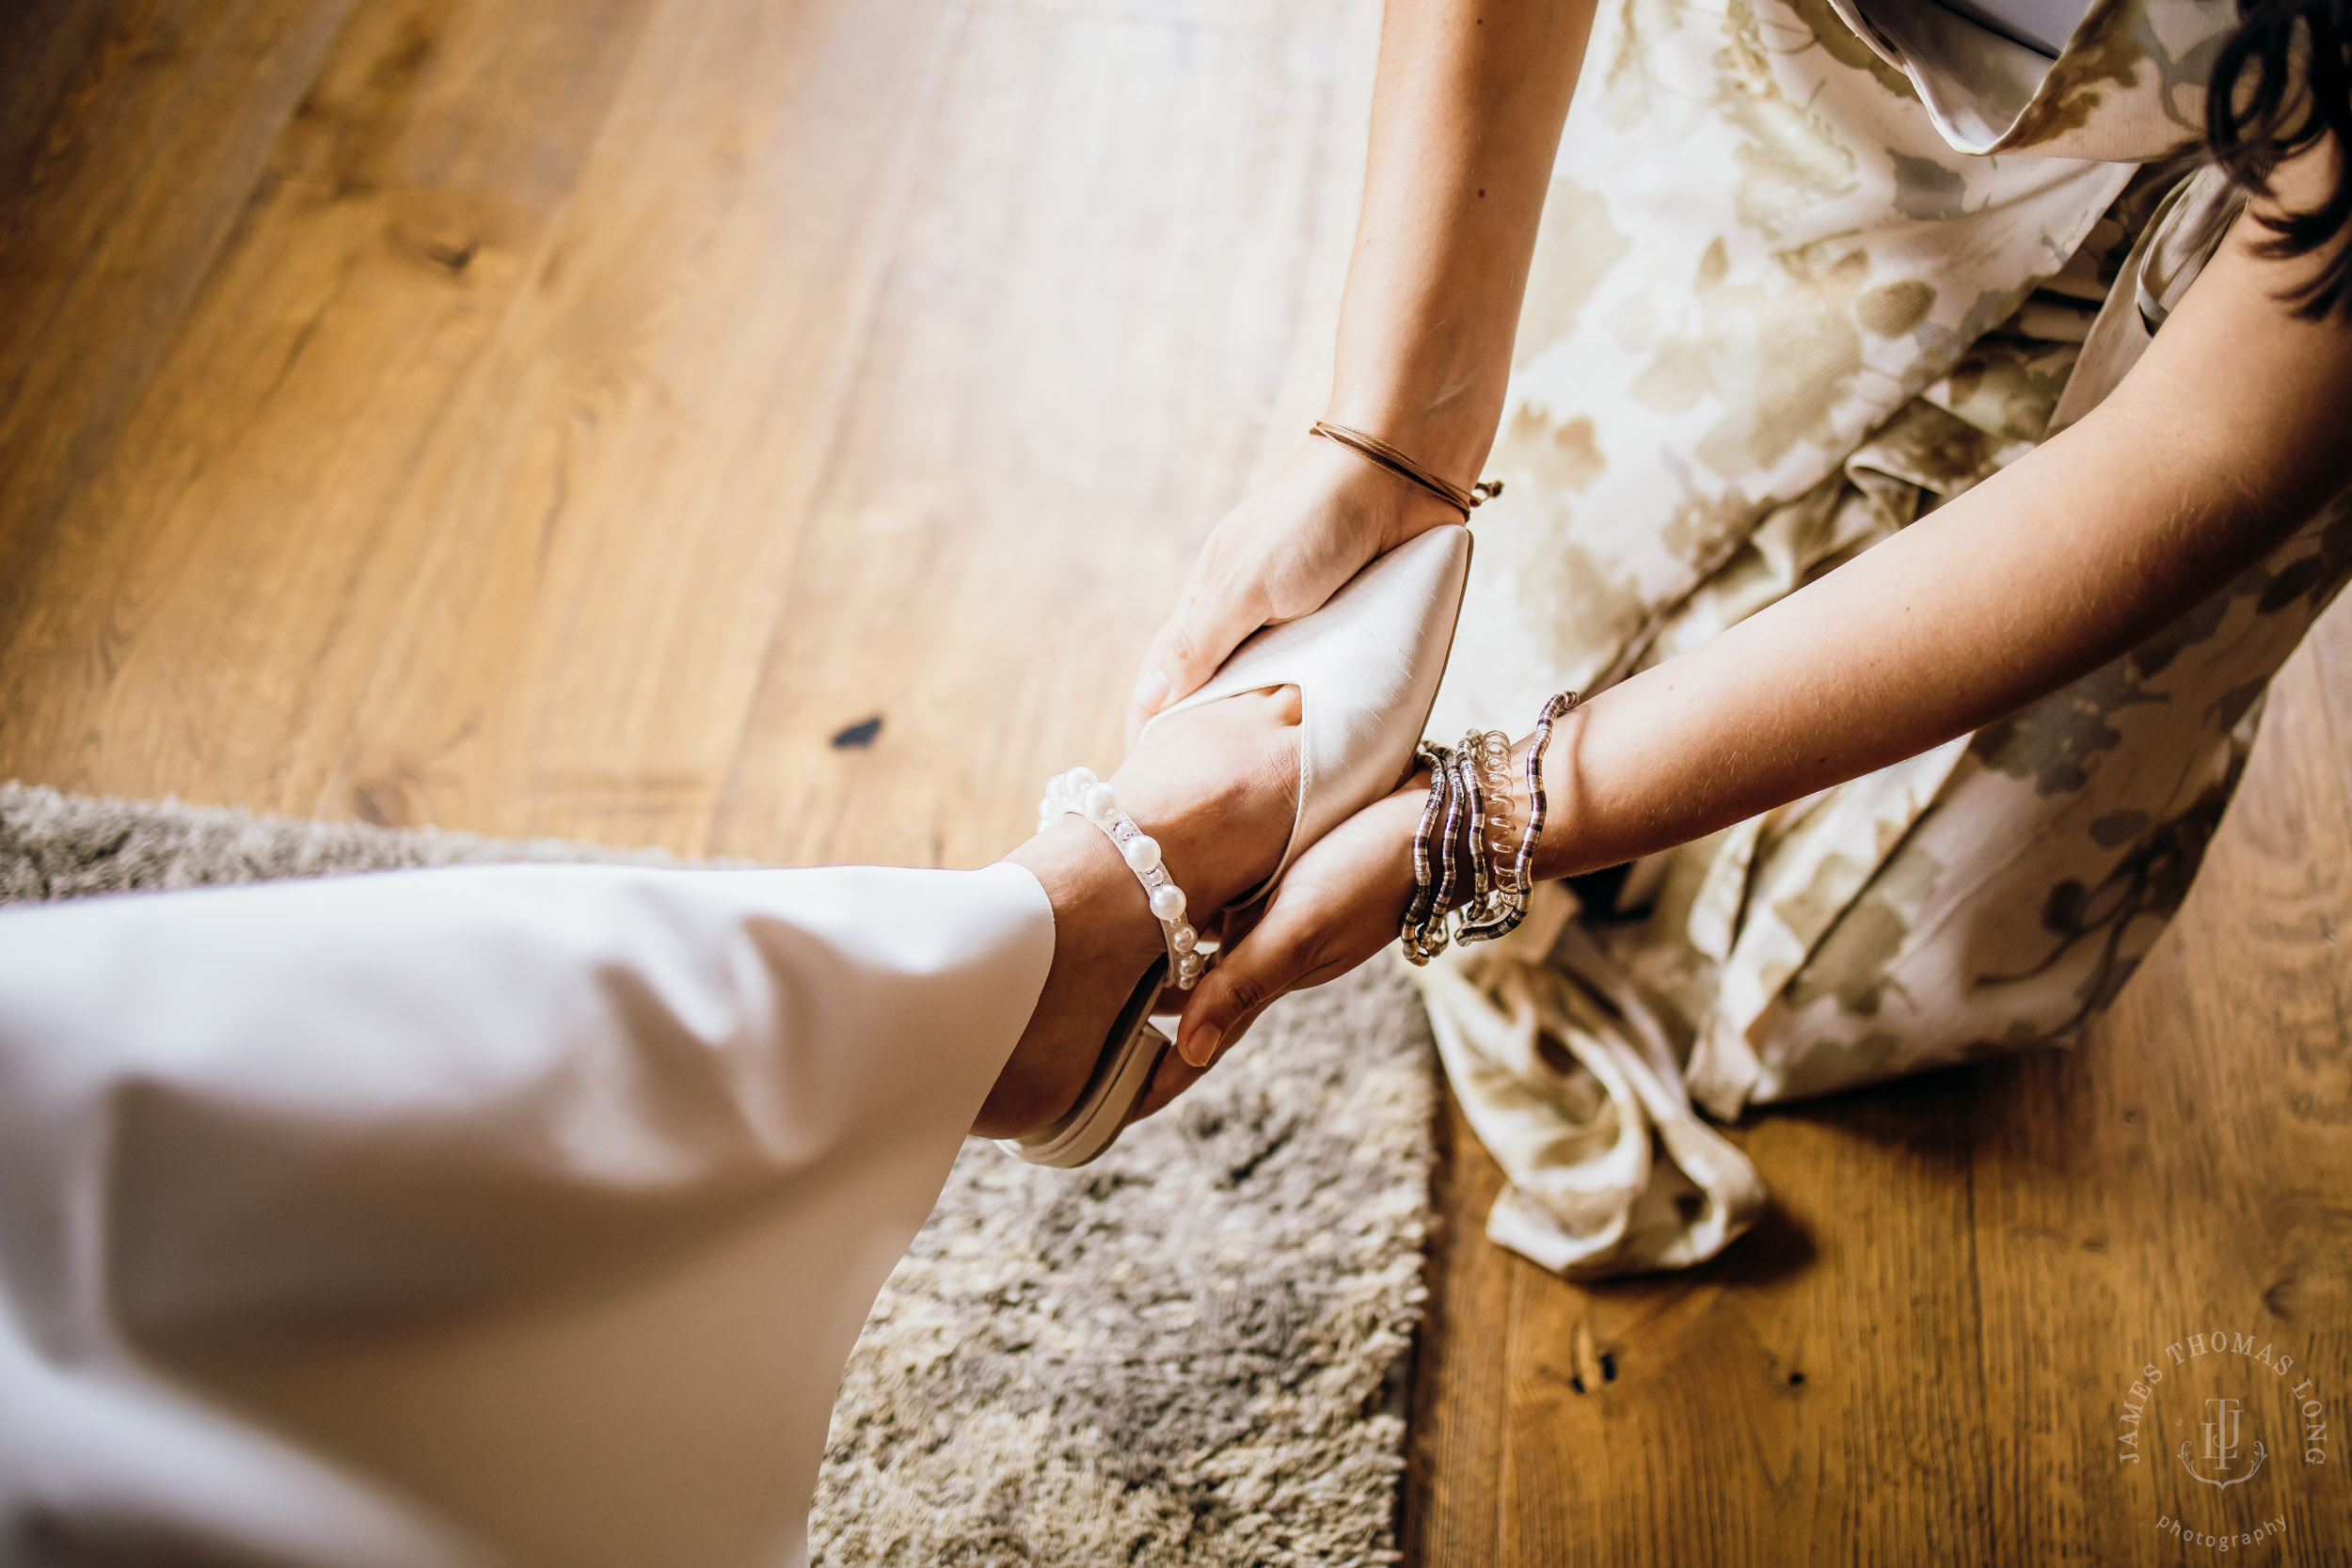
1002,524,1470,1168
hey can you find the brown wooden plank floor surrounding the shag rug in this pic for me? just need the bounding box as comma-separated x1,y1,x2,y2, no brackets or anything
0,0,2352,1568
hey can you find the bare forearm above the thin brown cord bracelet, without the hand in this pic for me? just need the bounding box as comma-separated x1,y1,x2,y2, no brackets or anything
1329,0,1593,484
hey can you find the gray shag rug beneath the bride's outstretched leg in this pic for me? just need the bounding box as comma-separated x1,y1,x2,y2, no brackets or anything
0,785,1435,1568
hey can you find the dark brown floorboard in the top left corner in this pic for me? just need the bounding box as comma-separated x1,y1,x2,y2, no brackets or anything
0,0,358,657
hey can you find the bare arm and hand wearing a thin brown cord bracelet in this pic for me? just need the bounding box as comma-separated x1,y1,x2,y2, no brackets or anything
1129,0,1595,736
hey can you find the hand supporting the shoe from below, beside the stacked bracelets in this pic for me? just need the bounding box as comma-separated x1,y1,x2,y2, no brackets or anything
1176,776,1430,1074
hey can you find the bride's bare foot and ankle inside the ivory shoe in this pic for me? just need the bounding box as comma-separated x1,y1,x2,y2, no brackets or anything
972,687,1298,1138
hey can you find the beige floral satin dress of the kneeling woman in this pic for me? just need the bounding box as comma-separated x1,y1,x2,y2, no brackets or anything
1423,0,2352,1275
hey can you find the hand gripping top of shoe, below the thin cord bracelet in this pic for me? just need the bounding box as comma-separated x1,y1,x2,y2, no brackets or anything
1127,437,1456,745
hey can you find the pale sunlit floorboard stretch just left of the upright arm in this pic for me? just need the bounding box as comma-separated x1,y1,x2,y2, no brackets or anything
713,5,1372,865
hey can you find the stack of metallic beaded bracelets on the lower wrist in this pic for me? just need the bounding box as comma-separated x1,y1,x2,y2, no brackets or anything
1397,691,1579,964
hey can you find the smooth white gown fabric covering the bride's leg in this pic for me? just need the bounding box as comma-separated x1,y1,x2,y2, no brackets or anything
0,865,1054,1568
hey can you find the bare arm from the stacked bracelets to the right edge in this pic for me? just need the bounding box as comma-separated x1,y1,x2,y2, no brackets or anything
1536,175,2352,877
